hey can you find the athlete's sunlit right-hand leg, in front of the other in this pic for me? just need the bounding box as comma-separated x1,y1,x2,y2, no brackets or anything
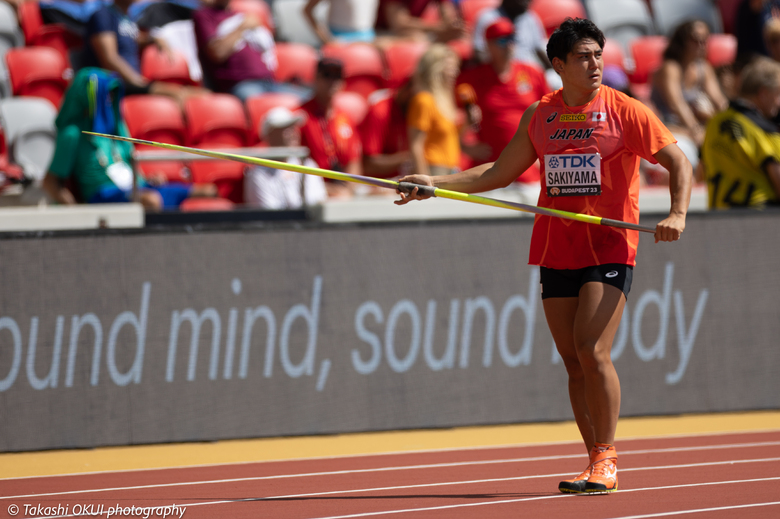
574,282,626,445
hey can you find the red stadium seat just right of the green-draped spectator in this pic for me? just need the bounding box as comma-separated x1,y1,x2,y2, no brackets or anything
122,95,191,182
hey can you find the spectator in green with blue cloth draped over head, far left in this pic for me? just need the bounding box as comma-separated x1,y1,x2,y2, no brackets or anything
43,67,216,211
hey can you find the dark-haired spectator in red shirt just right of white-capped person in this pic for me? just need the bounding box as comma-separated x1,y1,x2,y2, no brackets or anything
301,58,362,197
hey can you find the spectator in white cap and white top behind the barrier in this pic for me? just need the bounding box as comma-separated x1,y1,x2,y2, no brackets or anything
244,106,327,209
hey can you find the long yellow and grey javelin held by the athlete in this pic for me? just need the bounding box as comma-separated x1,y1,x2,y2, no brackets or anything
83,131,655,234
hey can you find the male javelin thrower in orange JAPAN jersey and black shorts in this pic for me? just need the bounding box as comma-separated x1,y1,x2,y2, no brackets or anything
396,19,692,493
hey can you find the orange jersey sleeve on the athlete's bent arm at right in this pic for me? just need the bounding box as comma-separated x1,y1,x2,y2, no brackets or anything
621,99,677,164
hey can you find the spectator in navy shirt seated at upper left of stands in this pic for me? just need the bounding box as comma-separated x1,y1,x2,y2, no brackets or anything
82,0,206,104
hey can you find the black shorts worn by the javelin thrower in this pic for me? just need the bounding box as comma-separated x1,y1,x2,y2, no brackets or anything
539,263,634,299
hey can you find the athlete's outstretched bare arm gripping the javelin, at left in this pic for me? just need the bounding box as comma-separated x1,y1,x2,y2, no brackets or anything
395,102,539,205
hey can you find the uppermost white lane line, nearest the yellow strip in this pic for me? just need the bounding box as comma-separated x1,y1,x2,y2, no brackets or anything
6,429,780,481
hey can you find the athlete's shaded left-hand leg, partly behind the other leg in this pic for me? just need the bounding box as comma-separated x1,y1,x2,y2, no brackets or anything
542,297,596,452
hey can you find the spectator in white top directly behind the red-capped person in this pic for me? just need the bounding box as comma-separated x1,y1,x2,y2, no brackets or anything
474,0,552,73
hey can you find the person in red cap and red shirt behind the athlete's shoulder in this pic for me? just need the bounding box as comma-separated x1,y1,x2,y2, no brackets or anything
456,18,550,184
